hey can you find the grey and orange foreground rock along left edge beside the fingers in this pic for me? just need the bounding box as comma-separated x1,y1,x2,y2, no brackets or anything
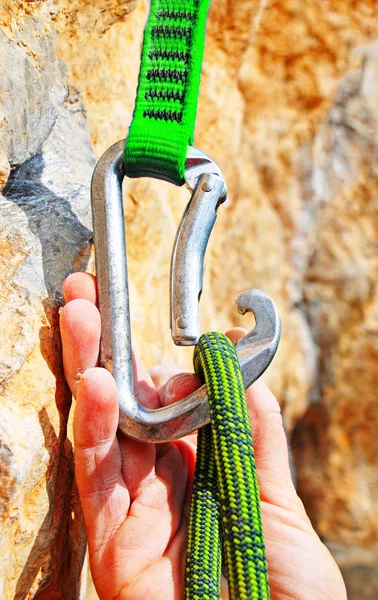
0,14,94,600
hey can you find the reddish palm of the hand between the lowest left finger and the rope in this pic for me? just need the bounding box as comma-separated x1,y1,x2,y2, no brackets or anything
89,438,193,600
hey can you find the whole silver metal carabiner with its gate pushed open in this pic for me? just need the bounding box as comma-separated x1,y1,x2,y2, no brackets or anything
91,141,280,442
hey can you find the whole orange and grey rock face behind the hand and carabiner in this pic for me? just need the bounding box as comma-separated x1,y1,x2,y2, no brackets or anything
0,0,378,600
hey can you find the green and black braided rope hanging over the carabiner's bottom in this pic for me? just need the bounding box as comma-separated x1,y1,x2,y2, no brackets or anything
185,333,270,600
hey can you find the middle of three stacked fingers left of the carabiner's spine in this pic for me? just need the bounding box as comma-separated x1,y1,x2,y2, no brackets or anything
60,300,101,395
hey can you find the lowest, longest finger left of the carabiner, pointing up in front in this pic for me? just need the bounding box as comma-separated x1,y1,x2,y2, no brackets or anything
73,368,130,549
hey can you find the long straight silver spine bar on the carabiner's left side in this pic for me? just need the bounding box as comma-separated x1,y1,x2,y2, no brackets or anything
91,140,133,410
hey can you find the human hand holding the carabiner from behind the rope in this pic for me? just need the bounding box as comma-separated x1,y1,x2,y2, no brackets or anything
60,273,347,600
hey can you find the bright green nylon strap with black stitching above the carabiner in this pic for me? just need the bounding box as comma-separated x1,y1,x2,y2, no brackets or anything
124,0,210,185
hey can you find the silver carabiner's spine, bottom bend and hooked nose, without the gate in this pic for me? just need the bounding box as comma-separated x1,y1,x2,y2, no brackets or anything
91,141,280,442
